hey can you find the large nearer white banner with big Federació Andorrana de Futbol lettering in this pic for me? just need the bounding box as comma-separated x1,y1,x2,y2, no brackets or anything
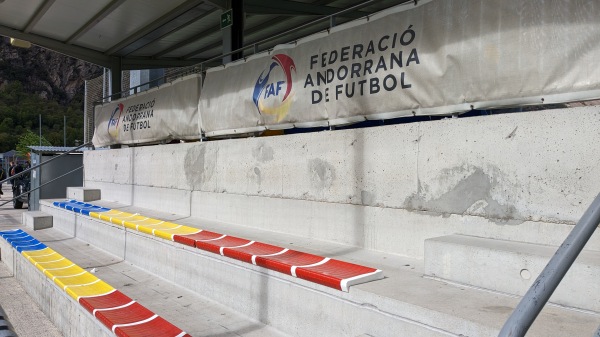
200,0,600,136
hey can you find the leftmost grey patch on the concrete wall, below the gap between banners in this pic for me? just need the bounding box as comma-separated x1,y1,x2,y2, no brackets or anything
183,145,216,190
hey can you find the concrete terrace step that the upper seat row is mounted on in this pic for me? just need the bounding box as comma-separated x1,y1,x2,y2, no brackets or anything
42,200,600,336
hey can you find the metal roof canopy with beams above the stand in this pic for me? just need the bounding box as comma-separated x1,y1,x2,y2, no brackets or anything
0,0,414,70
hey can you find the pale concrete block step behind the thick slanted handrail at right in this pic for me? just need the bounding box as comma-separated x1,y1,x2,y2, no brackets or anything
425,235,600,312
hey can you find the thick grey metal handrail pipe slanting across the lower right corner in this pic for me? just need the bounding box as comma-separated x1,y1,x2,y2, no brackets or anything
498,194,600,337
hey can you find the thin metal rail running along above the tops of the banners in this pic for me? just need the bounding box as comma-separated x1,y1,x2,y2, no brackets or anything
94,0,418,105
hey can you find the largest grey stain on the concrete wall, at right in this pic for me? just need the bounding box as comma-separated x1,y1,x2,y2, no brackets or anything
403,166,523,225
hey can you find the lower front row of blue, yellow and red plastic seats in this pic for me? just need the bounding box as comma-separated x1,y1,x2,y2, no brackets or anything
0,229,190,337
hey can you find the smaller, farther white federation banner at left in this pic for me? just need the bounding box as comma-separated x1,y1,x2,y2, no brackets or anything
92,74,201,147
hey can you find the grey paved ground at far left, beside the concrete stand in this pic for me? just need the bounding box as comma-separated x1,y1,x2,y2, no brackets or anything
0,184,62,337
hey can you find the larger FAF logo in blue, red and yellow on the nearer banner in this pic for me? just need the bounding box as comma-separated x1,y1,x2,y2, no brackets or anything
252,54,296,122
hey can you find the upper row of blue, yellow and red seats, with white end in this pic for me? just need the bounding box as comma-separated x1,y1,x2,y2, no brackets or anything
54,200,383,292
